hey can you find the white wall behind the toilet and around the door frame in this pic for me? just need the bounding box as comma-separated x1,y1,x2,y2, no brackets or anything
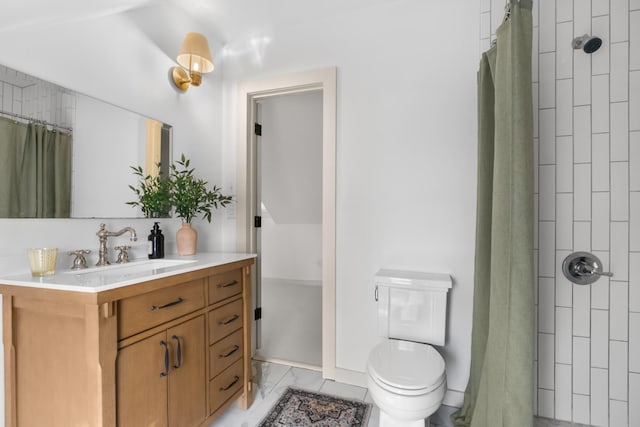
223,0,478,396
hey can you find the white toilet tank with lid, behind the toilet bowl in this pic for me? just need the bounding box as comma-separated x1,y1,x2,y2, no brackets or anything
374,270,452,345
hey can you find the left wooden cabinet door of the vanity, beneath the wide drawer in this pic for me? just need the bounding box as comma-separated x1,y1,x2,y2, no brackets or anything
116,332,170,427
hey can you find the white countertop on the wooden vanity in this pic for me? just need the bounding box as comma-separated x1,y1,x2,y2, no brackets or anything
0,252,256,293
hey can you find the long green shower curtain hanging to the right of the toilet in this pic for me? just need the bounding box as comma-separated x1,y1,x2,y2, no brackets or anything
452,0,535,427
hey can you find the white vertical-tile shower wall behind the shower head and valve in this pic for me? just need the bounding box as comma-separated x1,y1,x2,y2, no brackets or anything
480,0,640,427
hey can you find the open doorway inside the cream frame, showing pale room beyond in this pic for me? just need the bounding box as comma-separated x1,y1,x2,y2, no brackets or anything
256,90,322,368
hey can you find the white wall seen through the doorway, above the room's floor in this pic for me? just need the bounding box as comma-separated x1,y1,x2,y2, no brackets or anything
259,91,322,283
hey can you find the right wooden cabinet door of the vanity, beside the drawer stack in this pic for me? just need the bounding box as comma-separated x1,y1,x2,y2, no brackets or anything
168,315,207,427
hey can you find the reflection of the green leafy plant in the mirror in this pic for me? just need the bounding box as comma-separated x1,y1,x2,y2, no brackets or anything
127,163,172,218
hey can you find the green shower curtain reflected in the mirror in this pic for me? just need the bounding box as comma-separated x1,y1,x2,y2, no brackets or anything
0,117,72,218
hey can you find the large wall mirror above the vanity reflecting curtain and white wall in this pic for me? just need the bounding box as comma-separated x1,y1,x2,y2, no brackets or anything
0,66,172,218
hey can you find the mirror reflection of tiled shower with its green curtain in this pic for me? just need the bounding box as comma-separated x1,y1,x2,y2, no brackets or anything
0,68,74,218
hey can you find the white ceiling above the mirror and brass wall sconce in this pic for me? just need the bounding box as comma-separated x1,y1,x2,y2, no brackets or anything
0,0,403,45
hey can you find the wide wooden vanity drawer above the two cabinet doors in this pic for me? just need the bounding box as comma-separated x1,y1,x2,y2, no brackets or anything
118,279,205,339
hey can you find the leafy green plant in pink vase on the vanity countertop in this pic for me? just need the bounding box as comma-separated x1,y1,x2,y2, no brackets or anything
170,154,232,255
